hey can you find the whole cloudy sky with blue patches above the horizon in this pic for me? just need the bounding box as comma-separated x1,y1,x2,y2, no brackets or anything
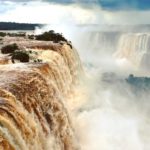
0,0,150,24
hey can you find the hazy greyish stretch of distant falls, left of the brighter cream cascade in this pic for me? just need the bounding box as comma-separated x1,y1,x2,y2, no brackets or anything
76,31,120,53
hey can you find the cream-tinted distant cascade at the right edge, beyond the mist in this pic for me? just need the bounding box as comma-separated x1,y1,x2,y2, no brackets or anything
115,33,150,66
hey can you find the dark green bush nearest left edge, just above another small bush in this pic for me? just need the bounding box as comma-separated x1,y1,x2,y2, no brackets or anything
1,43,19,54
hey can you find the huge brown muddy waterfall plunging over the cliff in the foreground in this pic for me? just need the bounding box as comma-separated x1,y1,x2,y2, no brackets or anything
0,39,82,150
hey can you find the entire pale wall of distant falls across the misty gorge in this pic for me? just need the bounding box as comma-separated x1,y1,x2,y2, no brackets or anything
76,30,150,69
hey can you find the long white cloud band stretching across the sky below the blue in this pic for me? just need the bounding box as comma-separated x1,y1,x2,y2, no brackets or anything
0,1,150,25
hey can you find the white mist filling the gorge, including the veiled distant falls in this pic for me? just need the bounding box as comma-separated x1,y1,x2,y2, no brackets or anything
54,24,150,150
